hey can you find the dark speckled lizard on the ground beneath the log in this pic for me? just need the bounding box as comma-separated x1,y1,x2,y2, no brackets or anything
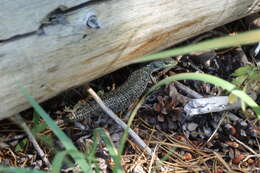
66,59,177,121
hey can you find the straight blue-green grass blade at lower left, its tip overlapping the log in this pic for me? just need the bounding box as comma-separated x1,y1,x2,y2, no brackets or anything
21,88,92,173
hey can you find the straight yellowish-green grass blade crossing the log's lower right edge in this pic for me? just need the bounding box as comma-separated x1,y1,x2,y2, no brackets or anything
133,29,260,63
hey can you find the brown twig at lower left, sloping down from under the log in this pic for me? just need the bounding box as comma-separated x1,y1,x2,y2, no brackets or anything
10,114,51,168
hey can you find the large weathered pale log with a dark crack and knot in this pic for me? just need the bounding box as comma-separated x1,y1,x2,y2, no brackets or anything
0,0,260,119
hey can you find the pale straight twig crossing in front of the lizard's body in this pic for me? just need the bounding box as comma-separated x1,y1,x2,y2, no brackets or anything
87,88,152,156
